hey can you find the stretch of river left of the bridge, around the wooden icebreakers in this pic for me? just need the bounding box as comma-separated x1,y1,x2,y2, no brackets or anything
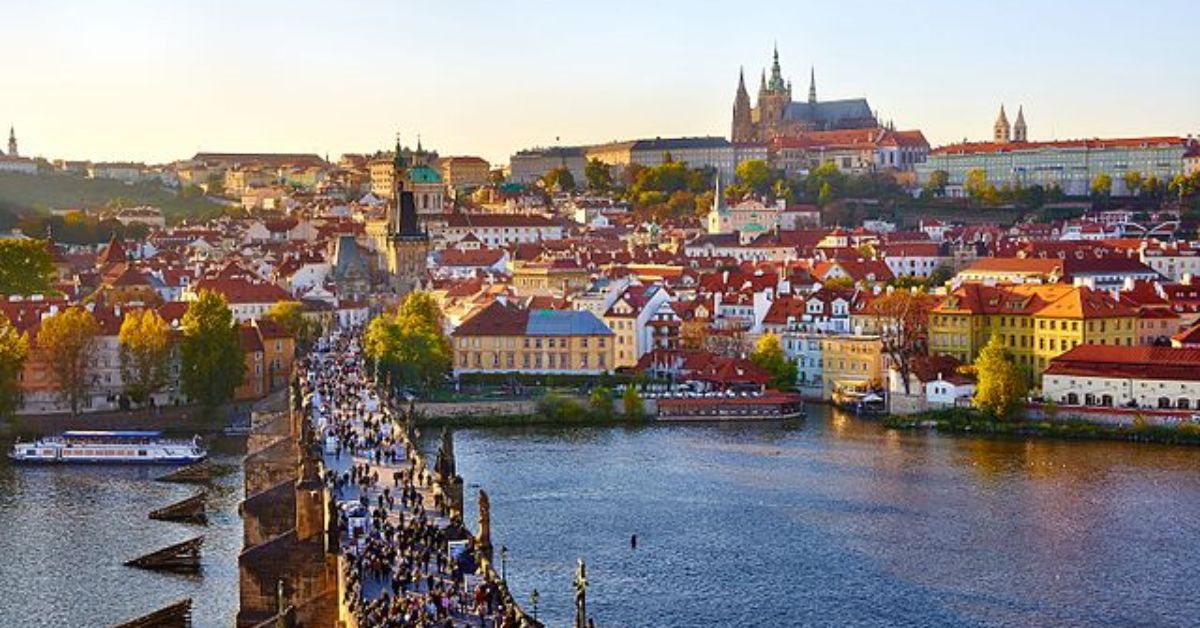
0,438,245,628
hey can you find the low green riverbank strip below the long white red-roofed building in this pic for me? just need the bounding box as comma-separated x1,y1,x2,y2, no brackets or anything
882,408,1200,445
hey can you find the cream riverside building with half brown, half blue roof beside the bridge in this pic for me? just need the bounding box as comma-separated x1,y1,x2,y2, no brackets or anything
450,299,613,376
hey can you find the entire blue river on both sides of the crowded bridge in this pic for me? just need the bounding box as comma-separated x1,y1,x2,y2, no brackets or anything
0,407,1200,627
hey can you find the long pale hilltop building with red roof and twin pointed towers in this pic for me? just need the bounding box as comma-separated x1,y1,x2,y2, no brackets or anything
917,107,1189,197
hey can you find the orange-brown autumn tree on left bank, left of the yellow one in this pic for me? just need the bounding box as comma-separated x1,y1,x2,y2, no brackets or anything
37,307,100,417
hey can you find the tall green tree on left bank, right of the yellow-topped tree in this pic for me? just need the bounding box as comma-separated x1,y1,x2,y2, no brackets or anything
180,291,246,412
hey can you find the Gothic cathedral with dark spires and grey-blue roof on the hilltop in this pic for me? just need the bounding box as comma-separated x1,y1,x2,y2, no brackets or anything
731,48,880,143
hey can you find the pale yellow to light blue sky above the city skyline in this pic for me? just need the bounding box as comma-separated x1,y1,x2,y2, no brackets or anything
7,0,1200,163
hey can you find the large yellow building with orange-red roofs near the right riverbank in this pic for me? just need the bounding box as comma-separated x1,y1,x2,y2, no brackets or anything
929,283,1138,378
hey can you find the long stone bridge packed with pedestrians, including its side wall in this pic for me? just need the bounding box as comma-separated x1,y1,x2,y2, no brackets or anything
238,334,541,628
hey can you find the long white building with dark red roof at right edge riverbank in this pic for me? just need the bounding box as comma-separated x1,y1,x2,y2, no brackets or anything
1042,345,1200,414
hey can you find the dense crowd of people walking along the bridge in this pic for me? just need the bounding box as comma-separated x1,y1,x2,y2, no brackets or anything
299,331,520,628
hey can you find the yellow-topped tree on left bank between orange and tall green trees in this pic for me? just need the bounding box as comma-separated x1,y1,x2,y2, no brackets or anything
118,310,170,405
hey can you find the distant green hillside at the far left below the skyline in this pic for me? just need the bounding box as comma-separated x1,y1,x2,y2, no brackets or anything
0,172,224,226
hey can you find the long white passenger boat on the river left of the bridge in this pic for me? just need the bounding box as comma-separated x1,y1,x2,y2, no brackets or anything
8,430,209,465
